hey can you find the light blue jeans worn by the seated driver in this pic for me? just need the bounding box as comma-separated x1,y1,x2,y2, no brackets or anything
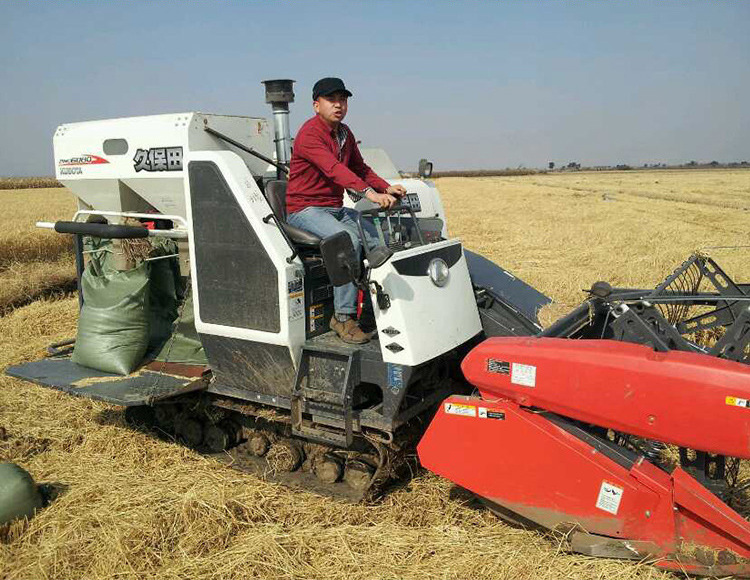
286,206,378,314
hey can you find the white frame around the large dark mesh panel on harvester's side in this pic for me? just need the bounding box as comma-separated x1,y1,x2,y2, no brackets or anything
185,151,305,364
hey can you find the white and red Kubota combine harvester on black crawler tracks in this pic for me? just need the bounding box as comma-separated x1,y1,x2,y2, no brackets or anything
7,80,750,576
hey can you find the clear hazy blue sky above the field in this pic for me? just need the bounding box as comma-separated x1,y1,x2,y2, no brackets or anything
0,0,750,176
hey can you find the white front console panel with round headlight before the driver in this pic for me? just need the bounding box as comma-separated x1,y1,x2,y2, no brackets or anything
371,240,482,365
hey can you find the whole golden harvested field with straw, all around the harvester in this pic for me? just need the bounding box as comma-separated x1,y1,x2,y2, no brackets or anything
0,170,750,580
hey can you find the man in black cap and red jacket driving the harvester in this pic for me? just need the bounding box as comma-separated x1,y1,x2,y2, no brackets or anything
286,77,406,344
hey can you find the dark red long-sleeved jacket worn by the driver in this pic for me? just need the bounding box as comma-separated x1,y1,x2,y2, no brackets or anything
286,115,389,214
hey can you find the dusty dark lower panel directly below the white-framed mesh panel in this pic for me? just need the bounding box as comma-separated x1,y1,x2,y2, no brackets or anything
200,334,297,398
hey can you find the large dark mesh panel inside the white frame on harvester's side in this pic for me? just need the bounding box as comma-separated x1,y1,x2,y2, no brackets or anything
189,161,280,332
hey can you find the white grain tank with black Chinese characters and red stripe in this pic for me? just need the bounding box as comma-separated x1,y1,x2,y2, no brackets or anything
53,113,274,217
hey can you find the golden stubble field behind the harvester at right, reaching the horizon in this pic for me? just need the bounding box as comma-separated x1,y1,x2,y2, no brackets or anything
437,170,750,305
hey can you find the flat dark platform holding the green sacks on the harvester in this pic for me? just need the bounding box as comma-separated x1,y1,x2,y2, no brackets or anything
5,357,208,407
